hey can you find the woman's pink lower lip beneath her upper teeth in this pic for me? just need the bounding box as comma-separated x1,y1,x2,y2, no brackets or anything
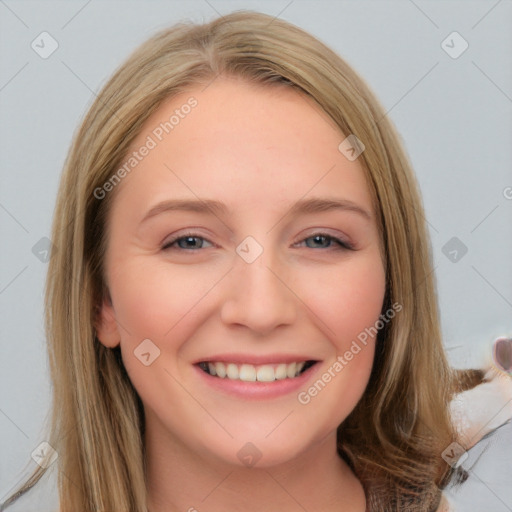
194,362,320,400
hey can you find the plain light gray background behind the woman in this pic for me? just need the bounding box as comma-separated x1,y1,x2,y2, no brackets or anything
0,0,512,512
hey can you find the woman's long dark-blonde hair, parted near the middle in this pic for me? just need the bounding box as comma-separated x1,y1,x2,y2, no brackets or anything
4,12,481,512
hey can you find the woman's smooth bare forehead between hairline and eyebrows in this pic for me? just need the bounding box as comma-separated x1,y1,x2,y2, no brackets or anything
109,77,373,220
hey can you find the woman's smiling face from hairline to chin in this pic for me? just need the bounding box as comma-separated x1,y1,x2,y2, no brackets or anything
97,78,385,467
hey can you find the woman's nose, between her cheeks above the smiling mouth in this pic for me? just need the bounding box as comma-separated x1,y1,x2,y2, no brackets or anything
221,251,298,335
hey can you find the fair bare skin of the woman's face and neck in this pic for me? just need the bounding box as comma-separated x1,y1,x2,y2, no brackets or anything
97,77,385,512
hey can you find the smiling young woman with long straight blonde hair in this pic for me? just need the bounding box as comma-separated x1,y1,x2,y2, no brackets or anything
1,12,504,512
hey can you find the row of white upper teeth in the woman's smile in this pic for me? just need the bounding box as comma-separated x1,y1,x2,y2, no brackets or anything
204,361,306,382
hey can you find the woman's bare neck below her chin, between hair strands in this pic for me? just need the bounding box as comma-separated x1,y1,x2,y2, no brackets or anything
145,417,365,512
